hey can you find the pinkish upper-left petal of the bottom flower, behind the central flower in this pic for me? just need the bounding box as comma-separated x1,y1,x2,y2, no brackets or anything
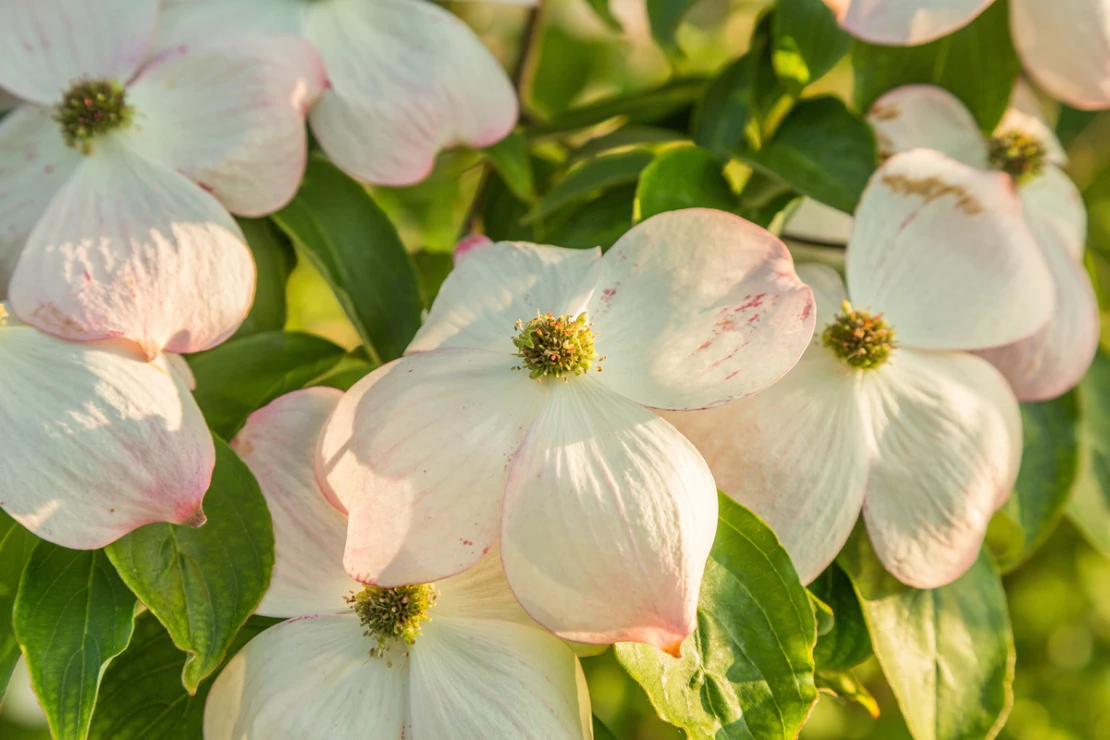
231,387,362,617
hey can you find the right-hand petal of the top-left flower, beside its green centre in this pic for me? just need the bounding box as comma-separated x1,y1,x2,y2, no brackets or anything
127,34,326,216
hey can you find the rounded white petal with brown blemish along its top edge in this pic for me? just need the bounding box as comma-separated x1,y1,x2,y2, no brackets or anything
847,150,1056,349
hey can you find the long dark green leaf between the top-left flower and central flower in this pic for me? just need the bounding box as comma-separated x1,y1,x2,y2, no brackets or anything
273,154,424,362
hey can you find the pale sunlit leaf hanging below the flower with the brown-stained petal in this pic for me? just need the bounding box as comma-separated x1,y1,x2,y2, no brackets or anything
838,527,1015,740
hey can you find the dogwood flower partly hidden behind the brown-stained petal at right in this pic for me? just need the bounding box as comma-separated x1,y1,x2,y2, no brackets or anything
867,84,1099,401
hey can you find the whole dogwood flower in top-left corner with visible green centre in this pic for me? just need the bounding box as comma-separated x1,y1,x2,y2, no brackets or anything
0,0,324,357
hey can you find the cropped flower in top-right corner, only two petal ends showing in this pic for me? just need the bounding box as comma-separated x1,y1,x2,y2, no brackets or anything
825,0,1110,109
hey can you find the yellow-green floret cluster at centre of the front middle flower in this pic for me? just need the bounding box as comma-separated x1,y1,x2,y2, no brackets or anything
513,311,605,381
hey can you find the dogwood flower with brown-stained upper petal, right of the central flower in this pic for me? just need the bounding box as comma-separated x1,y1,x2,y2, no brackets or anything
665,150,1053,588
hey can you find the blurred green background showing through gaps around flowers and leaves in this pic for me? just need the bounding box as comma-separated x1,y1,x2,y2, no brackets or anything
8,0,1110,740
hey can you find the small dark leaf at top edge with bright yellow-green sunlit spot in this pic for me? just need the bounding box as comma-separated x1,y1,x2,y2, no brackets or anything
771,0,851,94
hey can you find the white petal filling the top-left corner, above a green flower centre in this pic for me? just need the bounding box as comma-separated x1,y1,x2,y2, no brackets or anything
0,0,158,105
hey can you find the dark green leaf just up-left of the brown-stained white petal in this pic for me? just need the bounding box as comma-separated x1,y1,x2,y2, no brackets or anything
745,97,878,213
